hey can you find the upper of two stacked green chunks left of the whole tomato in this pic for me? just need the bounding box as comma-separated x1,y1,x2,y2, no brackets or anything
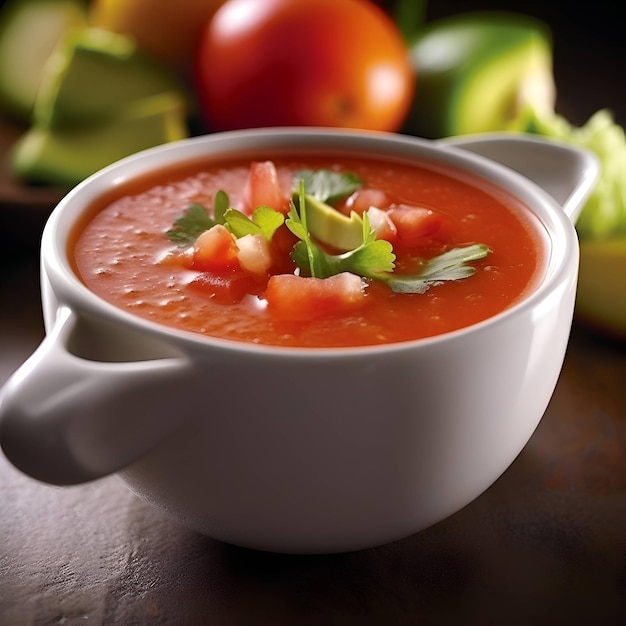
34,28,186,128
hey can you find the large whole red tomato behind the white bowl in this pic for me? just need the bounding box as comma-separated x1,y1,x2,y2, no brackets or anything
194,0,415,131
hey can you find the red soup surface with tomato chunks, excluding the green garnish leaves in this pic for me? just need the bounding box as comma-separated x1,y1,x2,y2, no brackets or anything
70,155,546,347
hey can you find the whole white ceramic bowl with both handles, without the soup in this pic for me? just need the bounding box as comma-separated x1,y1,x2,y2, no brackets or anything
0,129,597,553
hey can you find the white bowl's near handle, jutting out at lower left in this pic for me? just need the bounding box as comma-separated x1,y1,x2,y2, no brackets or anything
0,306,193,485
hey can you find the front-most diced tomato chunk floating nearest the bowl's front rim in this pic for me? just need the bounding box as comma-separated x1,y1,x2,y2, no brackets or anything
265,272,365,321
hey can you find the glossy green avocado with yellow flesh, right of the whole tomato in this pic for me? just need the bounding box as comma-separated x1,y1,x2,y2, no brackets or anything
403,11,556,138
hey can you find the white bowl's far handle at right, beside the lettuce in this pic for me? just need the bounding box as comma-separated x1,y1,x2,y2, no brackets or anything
439,132,600,224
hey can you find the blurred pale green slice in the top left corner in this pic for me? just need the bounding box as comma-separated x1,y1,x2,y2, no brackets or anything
0,0,87,121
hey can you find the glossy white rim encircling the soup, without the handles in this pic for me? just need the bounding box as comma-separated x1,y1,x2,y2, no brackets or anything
40,127,579,359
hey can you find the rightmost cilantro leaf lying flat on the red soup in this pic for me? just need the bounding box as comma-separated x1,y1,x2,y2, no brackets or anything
384,243,491,293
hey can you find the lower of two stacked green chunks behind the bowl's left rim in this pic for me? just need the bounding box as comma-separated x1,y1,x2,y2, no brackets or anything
10,92,187,187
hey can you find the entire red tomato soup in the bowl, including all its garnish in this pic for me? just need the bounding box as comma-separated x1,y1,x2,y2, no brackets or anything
70,153,547,347
